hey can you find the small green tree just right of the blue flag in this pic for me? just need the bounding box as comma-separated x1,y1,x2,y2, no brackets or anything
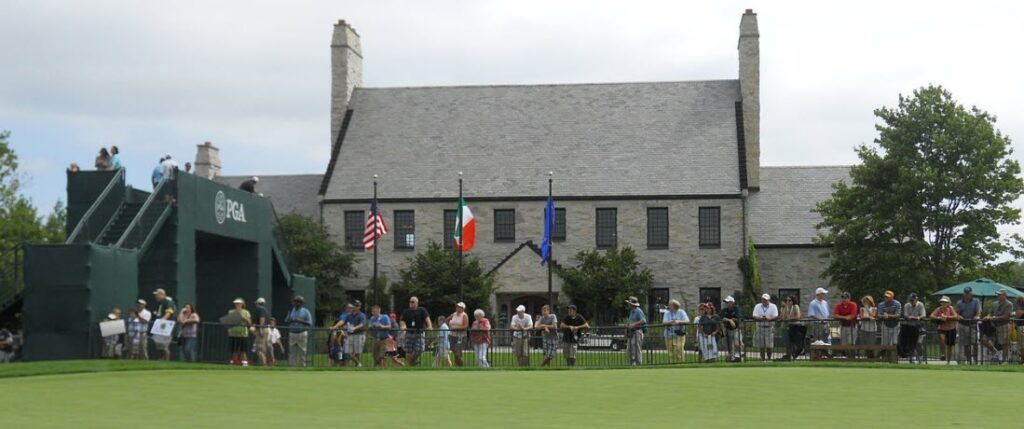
556,246,654,324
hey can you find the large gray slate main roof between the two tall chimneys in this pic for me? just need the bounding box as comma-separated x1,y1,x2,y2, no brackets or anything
326,80,740,199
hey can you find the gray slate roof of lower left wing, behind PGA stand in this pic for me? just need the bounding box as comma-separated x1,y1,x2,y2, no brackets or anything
215,174,324,221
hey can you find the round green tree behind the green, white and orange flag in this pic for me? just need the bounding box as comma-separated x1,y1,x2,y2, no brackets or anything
391,242,498,316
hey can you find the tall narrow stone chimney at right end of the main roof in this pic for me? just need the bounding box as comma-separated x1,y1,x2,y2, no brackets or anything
737,9,761,189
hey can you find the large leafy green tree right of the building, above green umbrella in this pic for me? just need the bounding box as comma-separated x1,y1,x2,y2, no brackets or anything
816,86,1024,296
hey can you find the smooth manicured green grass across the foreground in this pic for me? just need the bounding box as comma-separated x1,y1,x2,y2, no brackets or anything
0,361,1024,429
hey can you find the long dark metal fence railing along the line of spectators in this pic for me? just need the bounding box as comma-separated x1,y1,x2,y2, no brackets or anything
72,319,1024,368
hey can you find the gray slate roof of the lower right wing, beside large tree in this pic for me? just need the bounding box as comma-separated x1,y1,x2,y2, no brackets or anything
748,166,850,245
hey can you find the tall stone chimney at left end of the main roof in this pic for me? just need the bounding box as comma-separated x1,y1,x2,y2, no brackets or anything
331,19,362,146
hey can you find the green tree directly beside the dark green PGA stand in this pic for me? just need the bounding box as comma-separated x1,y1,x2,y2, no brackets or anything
278,214,355,320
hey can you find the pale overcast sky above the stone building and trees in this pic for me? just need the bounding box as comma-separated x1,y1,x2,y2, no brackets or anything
0,0,1024,238
